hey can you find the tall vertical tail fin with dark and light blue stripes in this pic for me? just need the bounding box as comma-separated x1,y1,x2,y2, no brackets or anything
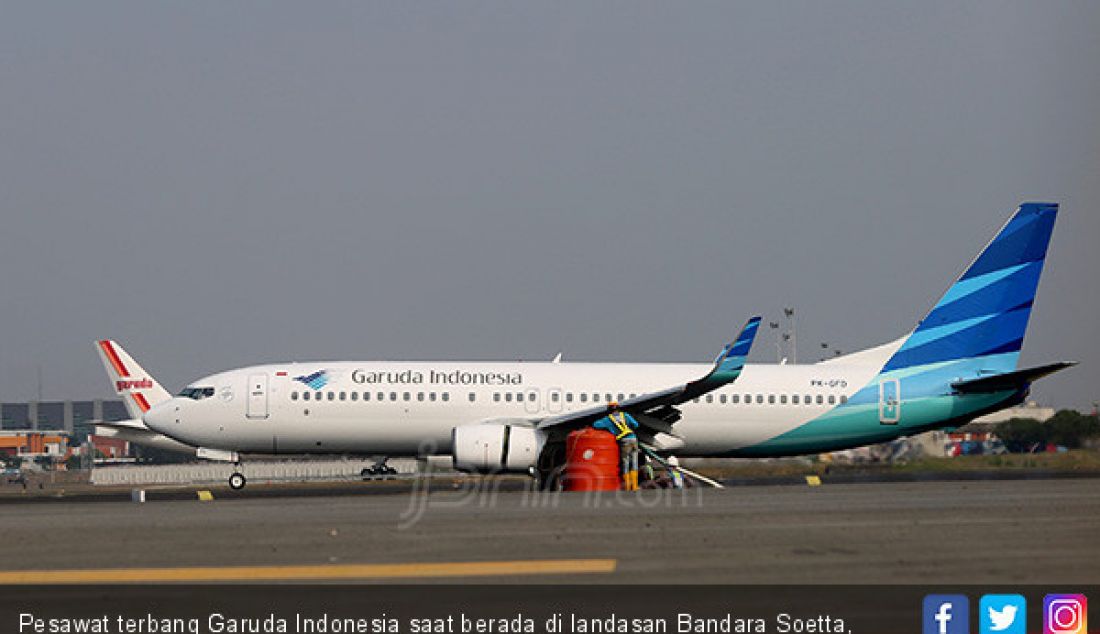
882,203,1058,372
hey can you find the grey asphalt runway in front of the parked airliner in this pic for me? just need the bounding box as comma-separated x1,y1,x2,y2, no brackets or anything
0,479,1100,584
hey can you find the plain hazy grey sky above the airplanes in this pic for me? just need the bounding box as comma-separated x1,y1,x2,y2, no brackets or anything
0,2,1100,407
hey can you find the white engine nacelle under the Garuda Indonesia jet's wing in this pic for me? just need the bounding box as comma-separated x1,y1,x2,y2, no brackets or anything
451,423,542,473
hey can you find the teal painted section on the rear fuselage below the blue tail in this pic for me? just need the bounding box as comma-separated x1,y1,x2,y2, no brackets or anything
730,391,1016,458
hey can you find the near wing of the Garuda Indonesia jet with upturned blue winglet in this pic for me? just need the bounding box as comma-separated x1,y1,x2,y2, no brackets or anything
536,317,760,435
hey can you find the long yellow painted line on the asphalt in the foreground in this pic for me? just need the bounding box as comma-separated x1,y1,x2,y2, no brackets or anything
0,559,617,586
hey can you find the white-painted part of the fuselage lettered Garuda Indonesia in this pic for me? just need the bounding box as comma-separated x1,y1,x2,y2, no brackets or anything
145,345,897,456
